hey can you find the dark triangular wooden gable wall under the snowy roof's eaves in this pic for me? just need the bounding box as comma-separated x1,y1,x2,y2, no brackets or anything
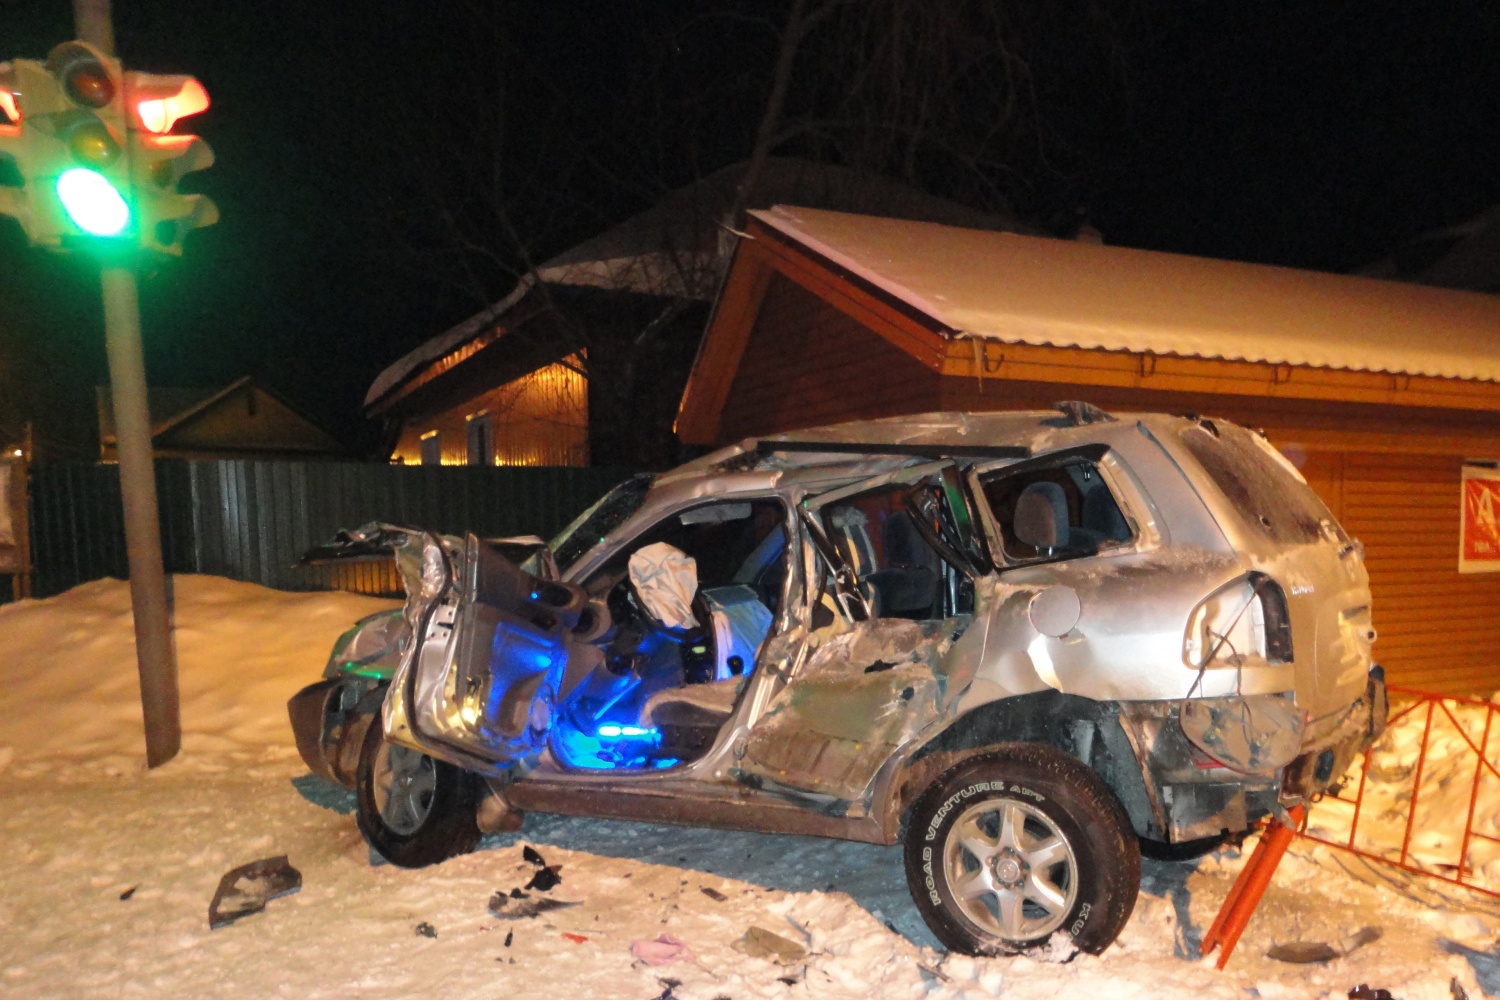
720,274,941,441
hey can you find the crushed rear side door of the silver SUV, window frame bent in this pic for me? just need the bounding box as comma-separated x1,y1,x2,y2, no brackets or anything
737,462,984,808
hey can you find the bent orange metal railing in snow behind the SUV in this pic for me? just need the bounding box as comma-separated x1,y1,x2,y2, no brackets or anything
1299,687,1500,898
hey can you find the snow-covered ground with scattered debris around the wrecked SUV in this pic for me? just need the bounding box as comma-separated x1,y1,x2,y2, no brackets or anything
0,576,1500,1000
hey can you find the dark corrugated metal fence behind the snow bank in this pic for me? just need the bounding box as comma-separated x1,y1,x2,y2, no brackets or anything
14,460,630,600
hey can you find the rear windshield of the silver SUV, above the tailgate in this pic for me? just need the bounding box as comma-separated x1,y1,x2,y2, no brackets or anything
1182,420,1332,544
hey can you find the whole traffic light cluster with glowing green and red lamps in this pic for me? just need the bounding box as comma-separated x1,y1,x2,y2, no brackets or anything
0,42,219,255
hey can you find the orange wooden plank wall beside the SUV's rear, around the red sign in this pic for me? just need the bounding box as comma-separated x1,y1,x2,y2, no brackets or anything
1307,453,1500,697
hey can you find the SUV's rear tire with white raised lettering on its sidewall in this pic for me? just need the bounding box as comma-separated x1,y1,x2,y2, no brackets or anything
905,744,1140,955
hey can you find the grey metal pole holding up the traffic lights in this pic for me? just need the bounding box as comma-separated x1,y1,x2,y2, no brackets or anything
74,0,182,768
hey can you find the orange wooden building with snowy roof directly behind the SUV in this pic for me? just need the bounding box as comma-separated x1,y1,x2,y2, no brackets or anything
677,207,1500,694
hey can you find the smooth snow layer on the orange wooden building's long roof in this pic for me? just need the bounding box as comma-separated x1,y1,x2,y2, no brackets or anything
752,205,1500,381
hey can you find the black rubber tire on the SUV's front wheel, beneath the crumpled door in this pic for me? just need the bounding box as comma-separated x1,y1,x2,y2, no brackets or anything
354,714,482,868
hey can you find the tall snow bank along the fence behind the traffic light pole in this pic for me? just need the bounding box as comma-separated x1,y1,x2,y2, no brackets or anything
0,576,393,768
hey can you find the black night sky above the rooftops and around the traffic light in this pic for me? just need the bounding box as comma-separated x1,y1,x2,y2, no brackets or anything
0,0,1500,457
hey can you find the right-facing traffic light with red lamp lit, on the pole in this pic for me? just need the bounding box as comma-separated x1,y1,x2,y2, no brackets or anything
125,72,219,255
